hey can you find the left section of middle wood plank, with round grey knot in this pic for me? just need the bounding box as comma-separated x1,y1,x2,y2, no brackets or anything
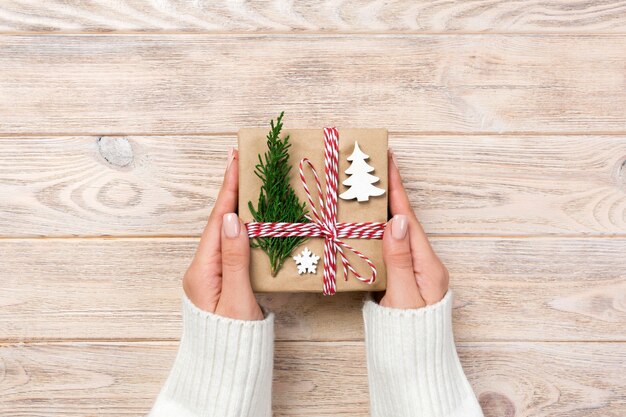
0,136,228,236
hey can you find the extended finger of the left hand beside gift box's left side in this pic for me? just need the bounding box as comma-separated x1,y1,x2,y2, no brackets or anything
194,149,239,263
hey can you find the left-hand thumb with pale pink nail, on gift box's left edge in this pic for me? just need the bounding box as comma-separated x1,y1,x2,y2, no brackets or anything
215,213,263,320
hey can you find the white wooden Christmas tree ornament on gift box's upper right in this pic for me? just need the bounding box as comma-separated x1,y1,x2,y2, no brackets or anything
339,141,385,201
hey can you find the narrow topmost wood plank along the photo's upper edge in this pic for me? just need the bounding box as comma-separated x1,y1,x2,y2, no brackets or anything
0,0,626,33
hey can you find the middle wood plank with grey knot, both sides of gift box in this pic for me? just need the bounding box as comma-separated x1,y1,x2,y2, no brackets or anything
0,134,626,237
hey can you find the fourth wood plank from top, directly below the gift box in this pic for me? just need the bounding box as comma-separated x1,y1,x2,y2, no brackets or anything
0,238,626,341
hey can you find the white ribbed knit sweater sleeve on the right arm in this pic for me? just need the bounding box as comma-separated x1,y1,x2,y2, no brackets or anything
363,291,483,417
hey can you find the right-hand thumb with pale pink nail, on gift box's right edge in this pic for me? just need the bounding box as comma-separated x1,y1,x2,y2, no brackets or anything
383,214,424,309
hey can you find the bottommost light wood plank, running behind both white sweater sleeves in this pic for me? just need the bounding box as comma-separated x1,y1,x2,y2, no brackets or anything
0,342,626,417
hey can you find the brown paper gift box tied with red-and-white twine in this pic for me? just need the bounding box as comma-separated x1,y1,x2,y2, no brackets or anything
238,119,387,294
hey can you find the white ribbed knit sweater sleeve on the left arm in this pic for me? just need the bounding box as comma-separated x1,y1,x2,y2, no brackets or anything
148,295,274,417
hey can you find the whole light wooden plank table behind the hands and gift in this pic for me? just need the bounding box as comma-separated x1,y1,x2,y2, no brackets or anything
0,0,626,417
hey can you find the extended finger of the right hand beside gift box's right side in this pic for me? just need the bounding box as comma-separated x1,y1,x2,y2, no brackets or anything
388,149,436,262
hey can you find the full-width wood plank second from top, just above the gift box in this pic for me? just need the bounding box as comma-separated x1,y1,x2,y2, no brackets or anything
0,34,626,135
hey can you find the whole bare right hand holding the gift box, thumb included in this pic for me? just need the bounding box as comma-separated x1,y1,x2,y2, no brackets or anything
380,151,449,309
